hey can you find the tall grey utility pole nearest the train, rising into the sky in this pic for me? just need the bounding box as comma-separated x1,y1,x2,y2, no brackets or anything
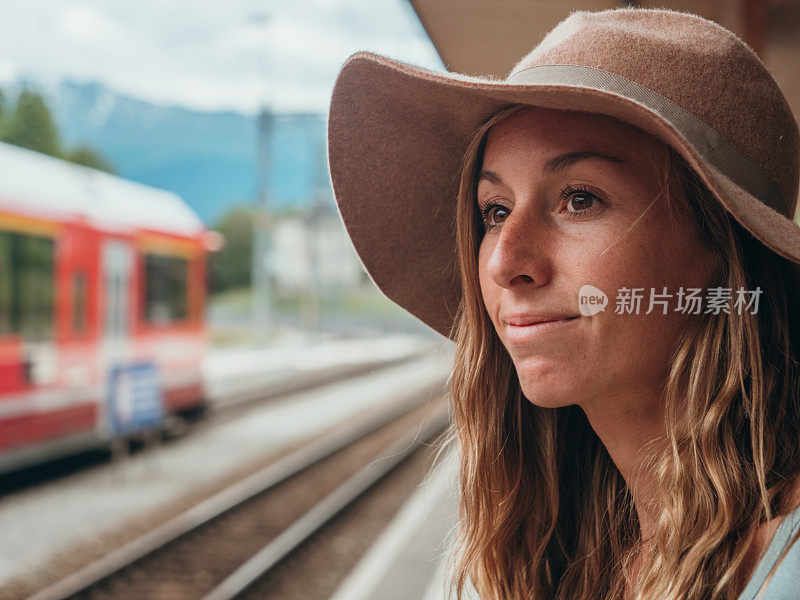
249,14,274,338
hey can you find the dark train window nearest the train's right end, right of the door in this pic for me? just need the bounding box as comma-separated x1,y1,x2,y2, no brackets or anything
144,254,189,324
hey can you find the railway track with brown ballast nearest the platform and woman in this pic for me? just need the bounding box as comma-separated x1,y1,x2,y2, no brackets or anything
29,386,448,600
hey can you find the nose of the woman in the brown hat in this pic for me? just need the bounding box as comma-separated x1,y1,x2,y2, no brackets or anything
486,211,552,288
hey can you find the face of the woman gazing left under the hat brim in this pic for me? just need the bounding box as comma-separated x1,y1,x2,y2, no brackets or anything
477,108,716,407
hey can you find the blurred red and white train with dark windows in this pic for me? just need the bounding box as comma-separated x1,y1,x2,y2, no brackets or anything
0,144,216,472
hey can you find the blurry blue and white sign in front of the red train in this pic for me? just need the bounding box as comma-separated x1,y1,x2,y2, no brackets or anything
108,362,164,435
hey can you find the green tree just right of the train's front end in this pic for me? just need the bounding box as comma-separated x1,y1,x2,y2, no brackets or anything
210,206,253,292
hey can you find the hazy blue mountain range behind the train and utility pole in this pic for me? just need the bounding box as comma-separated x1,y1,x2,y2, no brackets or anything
37,80,330,225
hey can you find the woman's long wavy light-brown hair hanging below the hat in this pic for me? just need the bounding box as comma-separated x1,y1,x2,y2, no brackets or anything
440,105,800,600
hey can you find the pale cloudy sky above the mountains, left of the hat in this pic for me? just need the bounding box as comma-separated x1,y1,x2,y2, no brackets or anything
0,0,443,112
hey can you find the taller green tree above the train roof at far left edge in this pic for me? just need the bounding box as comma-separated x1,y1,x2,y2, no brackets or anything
3,89,61,156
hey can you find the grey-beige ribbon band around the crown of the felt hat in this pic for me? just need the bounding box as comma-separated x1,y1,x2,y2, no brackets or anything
506,65,791,218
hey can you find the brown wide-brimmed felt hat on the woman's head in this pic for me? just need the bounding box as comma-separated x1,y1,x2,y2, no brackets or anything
328,8,800,336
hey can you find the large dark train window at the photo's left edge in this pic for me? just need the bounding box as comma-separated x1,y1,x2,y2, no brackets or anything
0,231,55,341
